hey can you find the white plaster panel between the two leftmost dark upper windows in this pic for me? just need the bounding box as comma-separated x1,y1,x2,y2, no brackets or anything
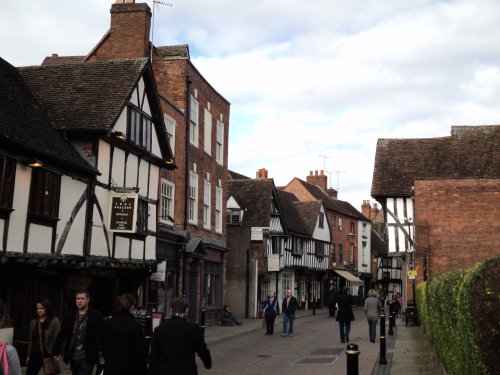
7,164,31,253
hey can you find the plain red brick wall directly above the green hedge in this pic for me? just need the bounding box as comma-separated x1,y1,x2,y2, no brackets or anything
415,179,500,281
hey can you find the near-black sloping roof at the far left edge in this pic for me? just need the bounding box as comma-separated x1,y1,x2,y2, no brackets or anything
0,58,97,174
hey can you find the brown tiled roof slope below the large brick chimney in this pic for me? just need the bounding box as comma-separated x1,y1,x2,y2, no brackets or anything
19,58,148,131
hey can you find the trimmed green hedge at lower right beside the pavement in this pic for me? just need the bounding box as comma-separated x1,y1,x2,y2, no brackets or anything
417,255,500,375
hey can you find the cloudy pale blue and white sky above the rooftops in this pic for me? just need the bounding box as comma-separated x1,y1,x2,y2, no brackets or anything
0,0,500,210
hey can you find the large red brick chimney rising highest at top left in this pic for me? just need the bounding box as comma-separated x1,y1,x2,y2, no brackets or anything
86,0,151,61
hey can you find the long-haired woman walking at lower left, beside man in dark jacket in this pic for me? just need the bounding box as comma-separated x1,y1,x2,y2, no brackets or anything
26,298,61,375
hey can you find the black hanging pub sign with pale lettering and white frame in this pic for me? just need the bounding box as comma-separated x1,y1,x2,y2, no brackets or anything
108,193,138,233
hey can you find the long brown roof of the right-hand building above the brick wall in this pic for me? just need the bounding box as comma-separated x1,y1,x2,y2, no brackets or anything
371,125,500,197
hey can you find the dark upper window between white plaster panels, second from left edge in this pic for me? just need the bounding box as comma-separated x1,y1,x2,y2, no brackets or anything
29,169,61,218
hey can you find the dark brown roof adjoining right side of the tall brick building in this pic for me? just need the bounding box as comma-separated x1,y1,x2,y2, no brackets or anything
227,179,276,227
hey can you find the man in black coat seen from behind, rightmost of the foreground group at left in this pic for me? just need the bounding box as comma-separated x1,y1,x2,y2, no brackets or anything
148,297,212,375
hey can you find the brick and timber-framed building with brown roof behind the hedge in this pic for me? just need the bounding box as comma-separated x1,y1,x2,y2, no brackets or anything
371,125,500,301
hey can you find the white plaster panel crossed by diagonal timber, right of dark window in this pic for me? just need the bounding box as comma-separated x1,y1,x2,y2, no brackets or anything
56,176,88,255
